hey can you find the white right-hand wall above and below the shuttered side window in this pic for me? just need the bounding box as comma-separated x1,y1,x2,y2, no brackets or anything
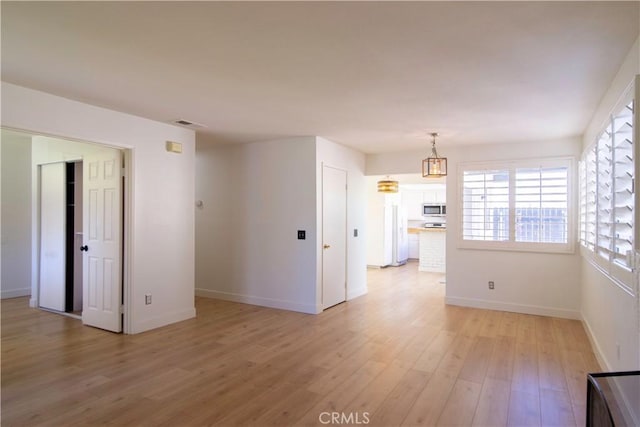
581,38,640,371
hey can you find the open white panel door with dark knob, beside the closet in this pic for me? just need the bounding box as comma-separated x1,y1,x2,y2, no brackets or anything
82,149,122,332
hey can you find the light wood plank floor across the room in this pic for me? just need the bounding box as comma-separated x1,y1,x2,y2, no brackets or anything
2,263,599,426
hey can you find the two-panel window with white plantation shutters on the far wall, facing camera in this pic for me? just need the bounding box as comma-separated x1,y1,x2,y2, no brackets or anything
459,158,575,253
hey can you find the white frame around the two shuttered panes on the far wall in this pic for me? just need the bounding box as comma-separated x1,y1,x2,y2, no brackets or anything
457,156,578,254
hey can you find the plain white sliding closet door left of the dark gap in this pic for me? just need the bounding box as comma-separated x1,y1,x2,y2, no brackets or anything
38,163,67,311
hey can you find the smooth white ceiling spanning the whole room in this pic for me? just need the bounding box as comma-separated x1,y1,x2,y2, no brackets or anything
1,1,640,153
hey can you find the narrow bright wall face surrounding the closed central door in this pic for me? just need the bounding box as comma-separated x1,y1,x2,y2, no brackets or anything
316,137,369,300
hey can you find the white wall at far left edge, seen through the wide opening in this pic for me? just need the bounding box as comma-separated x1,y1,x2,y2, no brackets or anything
0,130,31,298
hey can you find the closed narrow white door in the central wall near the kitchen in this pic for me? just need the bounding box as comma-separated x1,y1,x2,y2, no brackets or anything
322,166,347,309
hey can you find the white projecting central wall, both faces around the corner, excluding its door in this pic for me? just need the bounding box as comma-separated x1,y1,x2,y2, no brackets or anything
196,137,366,313
